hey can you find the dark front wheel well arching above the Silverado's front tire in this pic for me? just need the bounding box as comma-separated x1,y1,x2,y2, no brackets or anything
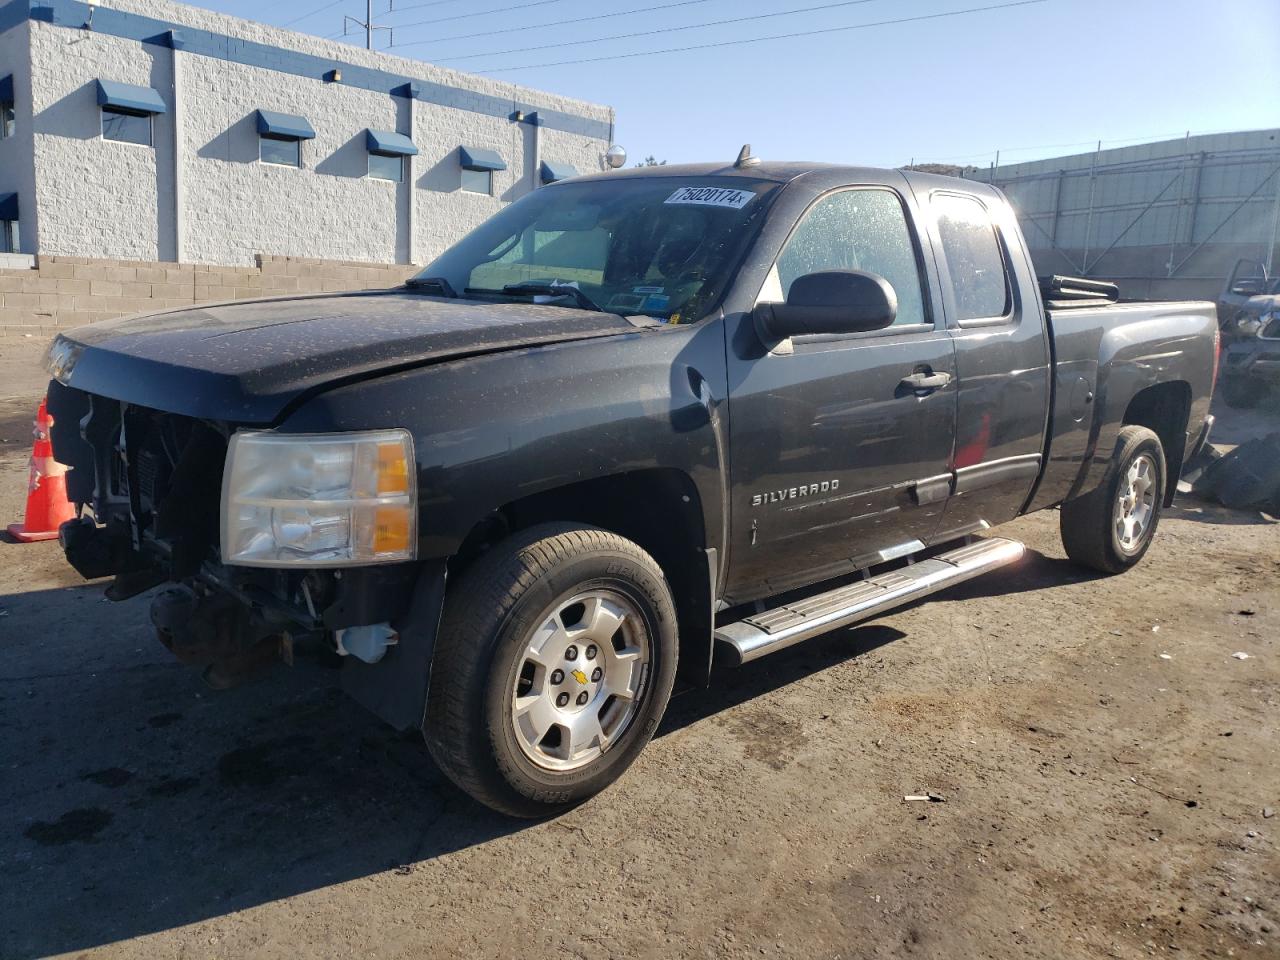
449,468,712,686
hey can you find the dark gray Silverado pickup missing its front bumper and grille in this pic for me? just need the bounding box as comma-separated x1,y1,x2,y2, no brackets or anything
49,151,1217,815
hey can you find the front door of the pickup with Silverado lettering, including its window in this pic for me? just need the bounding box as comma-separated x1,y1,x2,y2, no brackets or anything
724,187,956,603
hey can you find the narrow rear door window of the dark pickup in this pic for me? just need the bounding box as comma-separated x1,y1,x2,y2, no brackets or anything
931,193,1010,324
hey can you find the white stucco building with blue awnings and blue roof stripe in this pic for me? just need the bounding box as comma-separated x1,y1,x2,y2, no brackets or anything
0,0,613,272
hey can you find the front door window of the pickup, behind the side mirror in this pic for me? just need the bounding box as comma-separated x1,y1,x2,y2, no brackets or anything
760,189,929,326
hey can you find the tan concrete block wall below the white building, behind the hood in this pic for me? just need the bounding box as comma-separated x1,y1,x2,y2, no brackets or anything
0,253,416,338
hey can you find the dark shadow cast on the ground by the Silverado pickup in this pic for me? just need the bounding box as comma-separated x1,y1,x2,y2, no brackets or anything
0,585,901,957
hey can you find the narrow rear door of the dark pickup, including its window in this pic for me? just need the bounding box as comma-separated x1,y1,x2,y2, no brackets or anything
924,189,1051,540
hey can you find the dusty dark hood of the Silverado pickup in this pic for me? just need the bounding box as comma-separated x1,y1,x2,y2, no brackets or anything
49,289,637,424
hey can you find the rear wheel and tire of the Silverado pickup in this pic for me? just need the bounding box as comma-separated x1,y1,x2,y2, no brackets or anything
1059,426,1167,573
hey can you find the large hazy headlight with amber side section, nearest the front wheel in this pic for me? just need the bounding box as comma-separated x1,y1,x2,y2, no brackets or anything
221,430,417,567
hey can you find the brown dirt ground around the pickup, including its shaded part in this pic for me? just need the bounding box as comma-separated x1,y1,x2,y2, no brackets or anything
0,343,1280,960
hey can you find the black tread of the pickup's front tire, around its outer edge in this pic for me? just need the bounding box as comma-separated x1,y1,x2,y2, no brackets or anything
424,524,662,817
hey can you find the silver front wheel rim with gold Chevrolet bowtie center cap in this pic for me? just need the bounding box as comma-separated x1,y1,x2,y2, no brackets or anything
511,589,652,772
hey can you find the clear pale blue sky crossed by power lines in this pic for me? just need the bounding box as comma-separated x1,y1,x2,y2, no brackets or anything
192,0,1280,166
